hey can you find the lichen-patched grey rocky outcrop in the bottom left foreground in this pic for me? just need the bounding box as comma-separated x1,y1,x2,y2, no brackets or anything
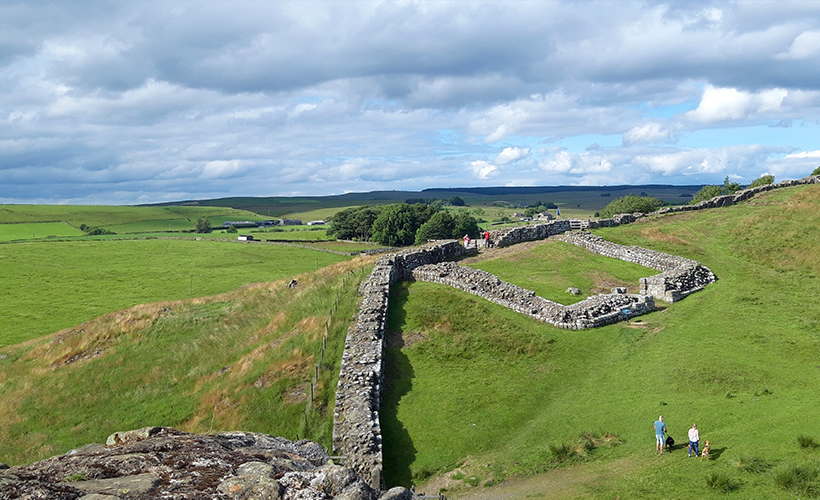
0,427,400,500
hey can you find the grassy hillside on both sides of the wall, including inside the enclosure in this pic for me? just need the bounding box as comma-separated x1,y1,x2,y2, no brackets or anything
0,185,820,499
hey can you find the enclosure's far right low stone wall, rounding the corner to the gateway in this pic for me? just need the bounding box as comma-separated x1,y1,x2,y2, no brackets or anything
554,231,717,302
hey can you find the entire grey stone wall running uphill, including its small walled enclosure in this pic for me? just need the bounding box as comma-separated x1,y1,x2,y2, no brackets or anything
333,176,820,489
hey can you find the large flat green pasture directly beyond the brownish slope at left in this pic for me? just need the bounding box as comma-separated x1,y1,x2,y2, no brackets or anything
0,239,347,346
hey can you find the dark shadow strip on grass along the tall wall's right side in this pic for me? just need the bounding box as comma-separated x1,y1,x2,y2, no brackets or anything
379,284,417,488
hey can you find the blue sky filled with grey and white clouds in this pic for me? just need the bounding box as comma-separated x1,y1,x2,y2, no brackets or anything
0,0,820,205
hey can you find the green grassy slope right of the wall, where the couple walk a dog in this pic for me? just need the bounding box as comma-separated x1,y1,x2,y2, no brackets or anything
383,186,820,498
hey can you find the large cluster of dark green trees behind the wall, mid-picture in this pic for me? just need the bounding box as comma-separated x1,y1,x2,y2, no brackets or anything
327,203,479,246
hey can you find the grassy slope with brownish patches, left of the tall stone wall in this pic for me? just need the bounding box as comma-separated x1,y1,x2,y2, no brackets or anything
0,258,373,464
